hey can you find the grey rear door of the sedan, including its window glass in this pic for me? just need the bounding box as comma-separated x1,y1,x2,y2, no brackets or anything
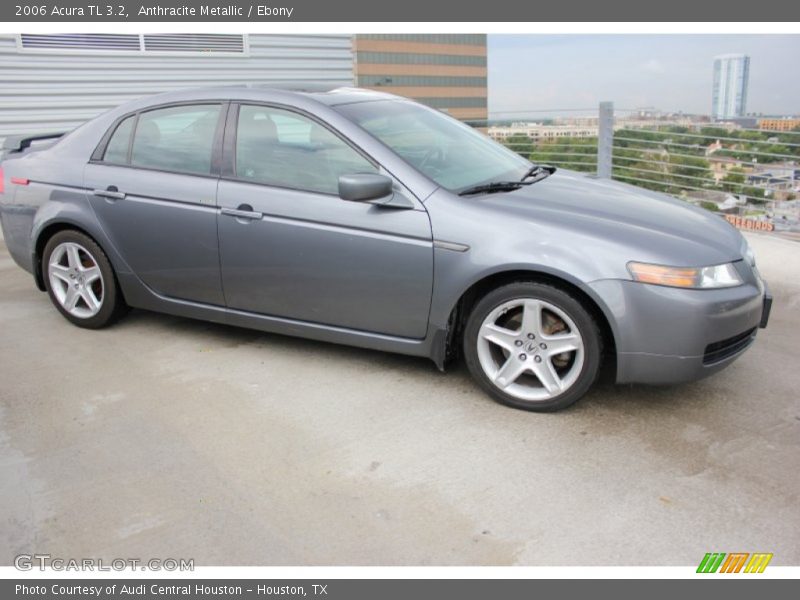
85,102,227,306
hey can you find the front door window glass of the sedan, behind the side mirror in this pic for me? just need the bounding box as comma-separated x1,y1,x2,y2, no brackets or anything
236,105,378,194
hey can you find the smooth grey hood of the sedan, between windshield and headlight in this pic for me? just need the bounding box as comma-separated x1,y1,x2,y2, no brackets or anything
478,169,743,266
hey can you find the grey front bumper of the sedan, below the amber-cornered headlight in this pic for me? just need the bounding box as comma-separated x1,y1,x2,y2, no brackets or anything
590,278,772,384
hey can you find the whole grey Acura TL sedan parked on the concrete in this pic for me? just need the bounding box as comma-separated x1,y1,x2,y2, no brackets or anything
0,86,771,410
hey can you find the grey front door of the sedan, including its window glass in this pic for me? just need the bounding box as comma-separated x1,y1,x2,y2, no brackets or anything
218,104,433,338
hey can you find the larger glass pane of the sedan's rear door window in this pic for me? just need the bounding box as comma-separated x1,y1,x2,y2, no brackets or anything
130,104,221,175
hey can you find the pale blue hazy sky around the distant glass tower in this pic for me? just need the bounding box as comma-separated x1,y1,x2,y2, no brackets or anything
488,35,800,117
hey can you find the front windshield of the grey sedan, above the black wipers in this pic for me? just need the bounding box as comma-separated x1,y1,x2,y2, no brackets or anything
336,100,531,192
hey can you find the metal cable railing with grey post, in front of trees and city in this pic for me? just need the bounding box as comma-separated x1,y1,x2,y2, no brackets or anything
472,102,800,231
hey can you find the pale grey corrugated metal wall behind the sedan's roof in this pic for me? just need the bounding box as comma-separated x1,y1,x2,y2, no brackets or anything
0,34,354,139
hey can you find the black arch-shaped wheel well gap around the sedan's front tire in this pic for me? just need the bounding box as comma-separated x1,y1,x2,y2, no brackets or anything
438,269,617,373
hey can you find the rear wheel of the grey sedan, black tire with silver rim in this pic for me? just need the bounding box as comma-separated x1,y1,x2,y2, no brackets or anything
42,229,128,329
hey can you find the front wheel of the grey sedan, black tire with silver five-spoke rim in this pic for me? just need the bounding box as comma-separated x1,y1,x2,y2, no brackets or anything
463,281,603,412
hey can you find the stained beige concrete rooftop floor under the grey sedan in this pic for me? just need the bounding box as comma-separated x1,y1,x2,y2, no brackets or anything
0,235,800,565
